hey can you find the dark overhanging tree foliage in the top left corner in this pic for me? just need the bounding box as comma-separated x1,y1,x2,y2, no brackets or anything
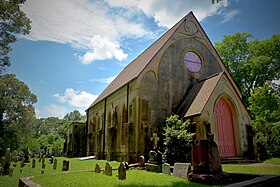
0,0,31,74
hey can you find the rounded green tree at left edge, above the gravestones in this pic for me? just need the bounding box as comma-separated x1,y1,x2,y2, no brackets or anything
0,74,37,149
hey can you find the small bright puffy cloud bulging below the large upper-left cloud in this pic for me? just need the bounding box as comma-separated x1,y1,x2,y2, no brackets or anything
79,35,127,64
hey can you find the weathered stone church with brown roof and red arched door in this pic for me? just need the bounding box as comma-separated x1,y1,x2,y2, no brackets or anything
86,12,252,163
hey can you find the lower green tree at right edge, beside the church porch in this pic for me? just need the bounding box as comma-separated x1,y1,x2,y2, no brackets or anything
249,83,280,159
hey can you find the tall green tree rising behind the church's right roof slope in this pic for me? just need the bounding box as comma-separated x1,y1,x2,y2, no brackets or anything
215,33,280,106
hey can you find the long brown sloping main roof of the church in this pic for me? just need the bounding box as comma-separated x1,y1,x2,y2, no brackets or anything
89,12,194,108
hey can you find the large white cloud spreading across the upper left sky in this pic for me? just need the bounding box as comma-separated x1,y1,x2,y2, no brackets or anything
23,0,148,63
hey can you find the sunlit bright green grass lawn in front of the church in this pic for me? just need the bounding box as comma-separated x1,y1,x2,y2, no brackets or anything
0,157,280,187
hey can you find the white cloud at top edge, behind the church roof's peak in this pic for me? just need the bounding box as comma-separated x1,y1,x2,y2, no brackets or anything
105,0,228,28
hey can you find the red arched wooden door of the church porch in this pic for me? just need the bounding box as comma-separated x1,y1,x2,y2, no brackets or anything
215,98,236,157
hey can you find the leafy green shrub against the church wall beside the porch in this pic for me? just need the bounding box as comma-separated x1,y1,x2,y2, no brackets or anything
163,115,193,164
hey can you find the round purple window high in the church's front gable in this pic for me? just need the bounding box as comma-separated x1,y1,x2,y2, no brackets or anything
184,51,202,73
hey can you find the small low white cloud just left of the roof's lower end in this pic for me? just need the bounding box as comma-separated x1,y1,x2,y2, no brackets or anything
54,88,98,110
